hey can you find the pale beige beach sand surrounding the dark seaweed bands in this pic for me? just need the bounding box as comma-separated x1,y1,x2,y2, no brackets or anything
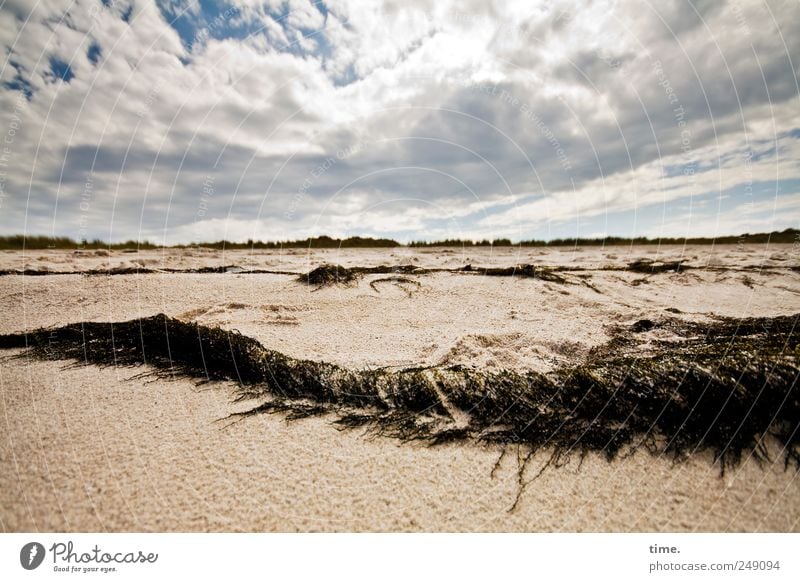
0,245,800,531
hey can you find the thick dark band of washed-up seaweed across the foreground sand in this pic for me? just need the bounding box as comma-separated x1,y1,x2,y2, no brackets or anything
0,314,800,502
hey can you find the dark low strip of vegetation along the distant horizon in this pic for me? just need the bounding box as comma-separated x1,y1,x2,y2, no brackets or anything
0,228,800,250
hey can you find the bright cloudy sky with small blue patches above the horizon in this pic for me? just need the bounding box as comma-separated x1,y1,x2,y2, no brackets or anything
0,0,800,244
